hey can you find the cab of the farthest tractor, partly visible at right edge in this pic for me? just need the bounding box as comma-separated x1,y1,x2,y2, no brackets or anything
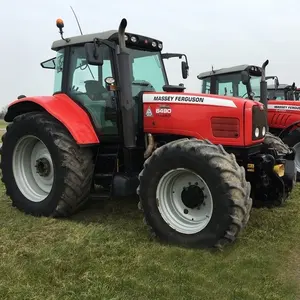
266,76,299,101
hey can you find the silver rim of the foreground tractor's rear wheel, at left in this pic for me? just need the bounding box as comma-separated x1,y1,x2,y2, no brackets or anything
12,135,54,202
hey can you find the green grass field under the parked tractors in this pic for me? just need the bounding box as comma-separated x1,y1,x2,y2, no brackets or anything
0,185,300,300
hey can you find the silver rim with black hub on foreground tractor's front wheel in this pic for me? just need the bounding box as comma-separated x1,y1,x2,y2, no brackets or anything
156,168,213,234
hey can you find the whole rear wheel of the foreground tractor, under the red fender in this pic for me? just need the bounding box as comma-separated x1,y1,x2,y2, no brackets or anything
0,112,94,217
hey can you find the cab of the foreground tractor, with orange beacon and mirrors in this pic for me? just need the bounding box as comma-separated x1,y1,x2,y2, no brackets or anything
41,19,188,141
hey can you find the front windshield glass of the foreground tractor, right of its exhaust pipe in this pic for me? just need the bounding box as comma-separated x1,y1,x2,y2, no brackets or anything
130,49,167,95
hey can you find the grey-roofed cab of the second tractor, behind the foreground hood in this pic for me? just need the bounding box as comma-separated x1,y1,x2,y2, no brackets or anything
197,65,262,100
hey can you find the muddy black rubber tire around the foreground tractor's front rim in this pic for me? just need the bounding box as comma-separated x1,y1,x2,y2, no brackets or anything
137,139,252,248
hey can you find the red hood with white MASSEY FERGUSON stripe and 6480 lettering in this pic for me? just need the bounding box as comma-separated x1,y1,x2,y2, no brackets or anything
142,92,267,147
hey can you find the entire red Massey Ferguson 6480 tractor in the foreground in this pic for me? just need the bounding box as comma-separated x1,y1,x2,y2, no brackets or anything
1,19,295,248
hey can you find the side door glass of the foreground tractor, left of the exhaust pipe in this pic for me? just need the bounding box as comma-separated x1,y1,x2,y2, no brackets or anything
68,45,118,135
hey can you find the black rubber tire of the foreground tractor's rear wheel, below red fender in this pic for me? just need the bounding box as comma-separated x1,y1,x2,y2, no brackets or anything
0,112,94,217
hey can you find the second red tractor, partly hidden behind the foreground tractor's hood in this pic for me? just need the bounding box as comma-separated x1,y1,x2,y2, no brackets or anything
197,65,300,181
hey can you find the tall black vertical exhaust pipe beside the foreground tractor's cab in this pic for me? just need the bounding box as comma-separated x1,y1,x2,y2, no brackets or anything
117,19,136,148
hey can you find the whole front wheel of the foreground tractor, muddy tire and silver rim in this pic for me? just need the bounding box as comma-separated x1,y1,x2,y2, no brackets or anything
137,139,252,248
